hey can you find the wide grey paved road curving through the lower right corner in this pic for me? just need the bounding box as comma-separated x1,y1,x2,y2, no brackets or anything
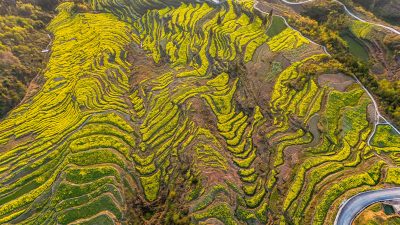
334,188,400,225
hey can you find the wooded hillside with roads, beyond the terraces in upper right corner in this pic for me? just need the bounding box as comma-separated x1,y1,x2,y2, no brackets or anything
258,0,400,126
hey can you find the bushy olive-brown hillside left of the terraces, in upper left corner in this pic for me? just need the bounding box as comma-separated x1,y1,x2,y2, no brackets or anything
0,0,53,118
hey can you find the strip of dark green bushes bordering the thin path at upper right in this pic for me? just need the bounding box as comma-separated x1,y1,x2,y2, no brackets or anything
289,10,400,124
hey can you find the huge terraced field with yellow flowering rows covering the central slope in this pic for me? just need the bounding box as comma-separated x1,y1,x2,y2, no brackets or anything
0,0,400,224
